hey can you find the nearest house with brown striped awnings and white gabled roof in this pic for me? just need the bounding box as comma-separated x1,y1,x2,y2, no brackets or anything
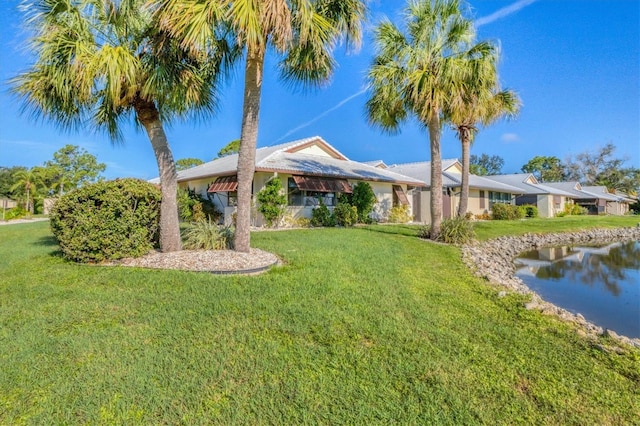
169,136,424,226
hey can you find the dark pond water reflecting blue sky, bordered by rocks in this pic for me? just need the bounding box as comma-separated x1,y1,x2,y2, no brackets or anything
515,241,640,338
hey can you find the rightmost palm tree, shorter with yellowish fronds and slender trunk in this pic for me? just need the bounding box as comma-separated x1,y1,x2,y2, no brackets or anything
445,48,520,217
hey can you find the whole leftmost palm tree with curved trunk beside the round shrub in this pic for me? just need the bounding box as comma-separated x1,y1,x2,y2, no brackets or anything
11,0,232,251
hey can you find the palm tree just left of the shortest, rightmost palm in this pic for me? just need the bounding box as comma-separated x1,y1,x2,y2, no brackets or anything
367,0,489,239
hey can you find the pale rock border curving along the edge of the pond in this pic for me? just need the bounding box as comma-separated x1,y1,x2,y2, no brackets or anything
461,224,640,348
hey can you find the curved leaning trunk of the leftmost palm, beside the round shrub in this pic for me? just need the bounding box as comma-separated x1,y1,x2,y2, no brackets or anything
134,98,182,252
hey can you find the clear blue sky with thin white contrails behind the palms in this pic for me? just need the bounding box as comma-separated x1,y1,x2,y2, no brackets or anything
0,0,640,179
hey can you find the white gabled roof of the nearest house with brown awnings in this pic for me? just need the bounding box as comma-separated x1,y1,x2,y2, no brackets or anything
170,136,424,186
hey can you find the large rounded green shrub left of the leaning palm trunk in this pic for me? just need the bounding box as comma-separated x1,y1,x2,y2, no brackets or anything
50,179,160,263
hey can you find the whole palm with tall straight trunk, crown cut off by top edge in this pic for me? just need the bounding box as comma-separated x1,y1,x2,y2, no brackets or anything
161,0,365,252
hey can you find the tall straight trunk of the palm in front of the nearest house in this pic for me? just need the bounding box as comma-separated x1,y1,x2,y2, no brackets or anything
234,47,264,253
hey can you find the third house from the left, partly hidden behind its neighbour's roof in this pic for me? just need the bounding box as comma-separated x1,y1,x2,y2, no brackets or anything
486,173,575,217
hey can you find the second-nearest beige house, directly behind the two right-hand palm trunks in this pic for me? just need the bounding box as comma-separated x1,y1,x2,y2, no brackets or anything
387,159,522,223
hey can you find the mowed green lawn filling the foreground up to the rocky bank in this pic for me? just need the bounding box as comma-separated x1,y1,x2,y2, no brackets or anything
0,218,640,425
